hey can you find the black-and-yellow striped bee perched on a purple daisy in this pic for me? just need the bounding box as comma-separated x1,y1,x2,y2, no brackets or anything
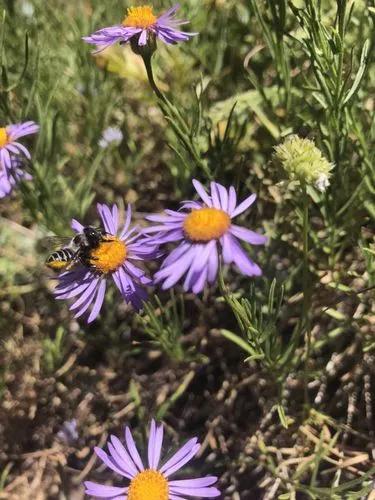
46,226,110,271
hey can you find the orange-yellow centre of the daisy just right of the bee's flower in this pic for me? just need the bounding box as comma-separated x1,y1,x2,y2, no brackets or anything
184,208,230,241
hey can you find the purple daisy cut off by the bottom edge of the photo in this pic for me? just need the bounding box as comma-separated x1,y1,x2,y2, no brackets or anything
85,420,220,500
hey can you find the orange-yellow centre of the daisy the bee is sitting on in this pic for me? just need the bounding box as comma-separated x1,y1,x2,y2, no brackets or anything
90,236,127,273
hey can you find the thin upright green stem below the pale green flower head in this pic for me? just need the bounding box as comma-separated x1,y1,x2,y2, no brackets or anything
302,184,311,409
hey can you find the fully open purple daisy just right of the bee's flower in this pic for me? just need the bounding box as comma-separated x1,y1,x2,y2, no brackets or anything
144,180,267,293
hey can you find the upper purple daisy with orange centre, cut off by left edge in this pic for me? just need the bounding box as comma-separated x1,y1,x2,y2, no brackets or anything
0,121,39,170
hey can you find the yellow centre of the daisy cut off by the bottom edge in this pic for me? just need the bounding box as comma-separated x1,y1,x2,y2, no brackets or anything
128,469,169,500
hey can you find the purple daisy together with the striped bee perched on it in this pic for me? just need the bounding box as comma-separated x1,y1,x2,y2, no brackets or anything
47,204,155,323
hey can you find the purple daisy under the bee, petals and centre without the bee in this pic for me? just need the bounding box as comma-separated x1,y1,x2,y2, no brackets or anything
54,204,155,323
